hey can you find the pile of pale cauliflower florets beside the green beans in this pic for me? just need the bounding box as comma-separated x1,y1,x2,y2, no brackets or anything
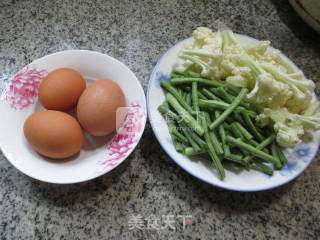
175,27,320,147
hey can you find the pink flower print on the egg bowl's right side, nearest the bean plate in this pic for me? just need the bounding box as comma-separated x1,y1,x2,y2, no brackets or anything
102,103,146,168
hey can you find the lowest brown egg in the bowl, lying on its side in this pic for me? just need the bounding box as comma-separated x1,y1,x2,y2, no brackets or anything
23,110,83,159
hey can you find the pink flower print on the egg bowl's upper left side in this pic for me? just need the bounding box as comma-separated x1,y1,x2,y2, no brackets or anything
5,68,47,110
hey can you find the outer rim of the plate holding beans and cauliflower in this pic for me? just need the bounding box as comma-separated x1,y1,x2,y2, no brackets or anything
146,33,319,192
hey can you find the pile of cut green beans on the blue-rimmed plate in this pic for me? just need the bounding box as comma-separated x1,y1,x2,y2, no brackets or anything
158,71,288,180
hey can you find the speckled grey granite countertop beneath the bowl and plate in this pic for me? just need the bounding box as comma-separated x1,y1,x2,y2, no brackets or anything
0,0,320,239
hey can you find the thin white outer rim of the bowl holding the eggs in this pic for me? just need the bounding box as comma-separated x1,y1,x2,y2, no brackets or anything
0,49,148,185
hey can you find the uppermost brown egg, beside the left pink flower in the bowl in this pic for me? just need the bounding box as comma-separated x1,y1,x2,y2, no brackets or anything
39,68,86,111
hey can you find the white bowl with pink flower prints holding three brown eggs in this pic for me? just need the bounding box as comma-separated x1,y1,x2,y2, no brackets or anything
0,50,147,184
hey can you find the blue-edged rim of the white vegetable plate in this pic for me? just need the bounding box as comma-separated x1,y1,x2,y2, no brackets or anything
147,35,319,192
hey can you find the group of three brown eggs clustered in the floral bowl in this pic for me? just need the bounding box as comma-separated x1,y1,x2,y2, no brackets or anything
23,68,126,159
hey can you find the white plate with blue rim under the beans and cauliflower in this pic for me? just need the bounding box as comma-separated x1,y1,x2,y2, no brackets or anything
147,34,319,192
